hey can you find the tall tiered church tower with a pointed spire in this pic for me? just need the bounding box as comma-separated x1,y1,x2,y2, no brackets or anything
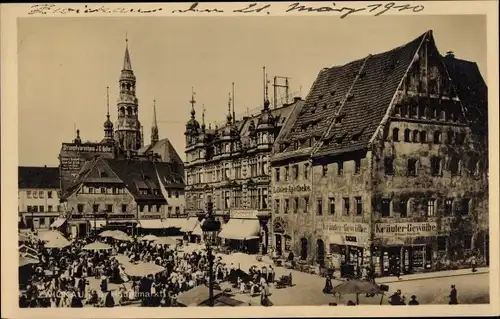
115,39,143,155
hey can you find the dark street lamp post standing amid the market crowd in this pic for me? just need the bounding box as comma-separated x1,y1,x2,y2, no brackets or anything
201,196,221,307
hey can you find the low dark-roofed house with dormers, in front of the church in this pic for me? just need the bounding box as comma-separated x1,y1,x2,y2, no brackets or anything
59,157,184,236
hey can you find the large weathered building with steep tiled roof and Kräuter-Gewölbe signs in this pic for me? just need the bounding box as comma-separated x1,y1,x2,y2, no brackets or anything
271,31,488,275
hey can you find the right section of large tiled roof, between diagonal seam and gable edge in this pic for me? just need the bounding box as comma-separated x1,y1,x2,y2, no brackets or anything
315,33,430,155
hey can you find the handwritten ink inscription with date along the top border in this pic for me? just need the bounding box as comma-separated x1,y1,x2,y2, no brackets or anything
28,2,425,19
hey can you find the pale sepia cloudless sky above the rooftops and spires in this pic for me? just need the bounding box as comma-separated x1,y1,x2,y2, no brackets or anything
18,15,487,166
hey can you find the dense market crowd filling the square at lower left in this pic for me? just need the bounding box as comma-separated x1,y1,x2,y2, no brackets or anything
19,231,275,308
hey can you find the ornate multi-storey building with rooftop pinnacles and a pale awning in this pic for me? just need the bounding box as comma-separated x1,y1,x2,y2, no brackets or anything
185,76,304,252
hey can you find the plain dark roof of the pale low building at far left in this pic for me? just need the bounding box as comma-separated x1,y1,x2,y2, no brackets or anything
18,166,60,189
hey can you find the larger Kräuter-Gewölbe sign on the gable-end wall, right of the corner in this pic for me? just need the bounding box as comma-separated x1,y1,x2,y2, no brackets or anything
374,222,438,237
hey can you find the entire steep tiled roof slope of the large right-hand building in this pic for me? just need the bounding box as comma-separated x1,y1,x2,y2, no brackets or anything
273,31,430,160
